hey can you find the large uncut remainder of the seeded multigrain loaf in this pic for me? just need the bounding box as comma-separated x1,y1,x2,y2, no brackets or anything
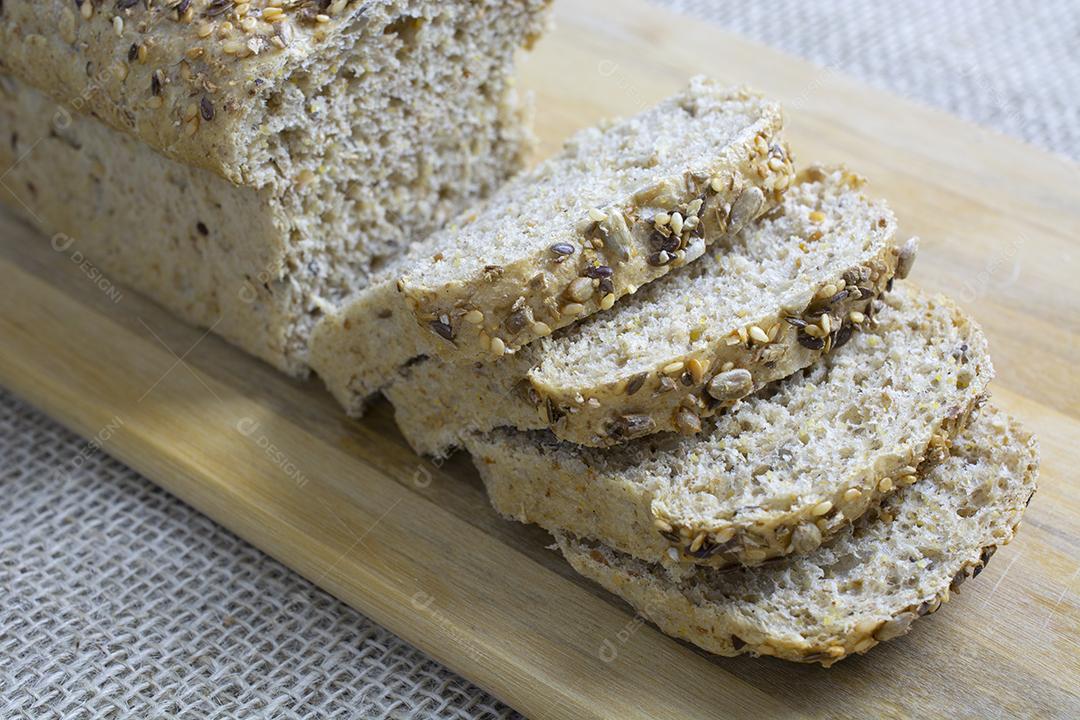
0,0,549,373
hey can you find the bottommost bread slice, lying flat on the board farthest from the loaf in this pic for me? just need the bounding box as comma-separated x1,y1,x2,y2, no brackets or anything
556,408,1039,667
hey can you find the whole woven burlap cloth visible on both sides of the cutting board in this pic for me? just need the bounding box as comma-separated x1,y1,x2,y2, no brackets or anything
0,0,1080,720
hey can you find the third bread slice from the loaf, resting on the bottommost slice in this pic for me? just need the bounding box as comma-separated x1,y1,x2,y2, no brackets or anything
465,280,994,567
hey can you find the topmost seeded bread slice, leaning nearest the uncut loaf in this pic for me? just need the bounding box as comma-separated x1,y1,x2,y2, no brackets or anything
313,78,793,415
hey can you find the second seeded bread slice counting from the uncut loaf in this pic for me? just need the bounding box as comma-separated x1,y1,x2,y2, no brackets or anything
386,168,914,454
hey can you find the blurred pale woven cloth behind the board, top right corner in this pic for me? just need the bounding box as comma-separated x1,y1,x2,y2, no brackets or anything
652,0,1080,160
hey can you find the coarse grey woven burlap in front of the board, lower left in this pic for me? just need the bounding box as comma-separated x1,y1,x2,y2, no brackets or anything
0,393,513,720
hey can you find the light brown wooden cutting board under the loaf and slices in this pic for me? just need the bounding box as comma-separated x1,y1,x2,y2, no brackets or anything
0,0,1080,718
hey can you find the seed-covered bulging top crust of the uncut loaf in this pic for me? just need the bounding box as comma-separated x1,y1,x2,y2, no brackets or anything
0,0,360,185
